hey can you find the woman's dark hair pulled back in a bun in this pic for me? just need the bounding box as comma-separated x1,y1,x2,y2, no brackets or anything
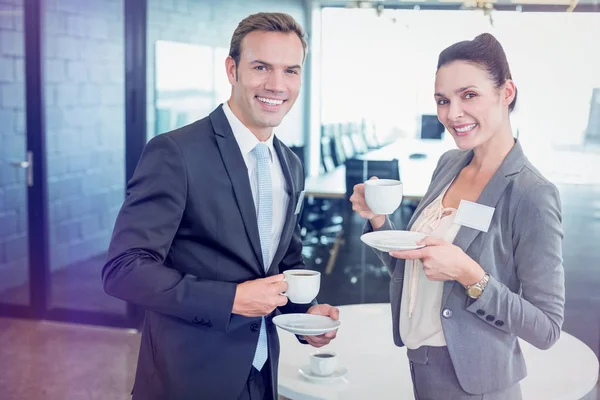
437,33,517,111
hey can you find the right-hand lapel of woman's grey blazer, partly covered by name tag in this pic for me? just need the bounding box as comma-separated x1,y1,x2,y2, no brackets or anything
442,141,526,304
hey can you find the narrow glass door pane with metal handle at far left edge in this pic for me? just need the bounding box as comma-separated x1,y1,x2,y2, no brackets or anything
0,2,35,312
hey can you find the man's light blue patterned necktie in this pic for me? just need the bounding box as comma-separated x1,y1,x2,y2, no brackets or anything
252,143,273,371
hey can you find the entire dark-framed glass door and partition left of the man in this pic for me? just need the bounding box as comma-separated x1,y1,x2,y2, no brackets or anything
0,0,145,327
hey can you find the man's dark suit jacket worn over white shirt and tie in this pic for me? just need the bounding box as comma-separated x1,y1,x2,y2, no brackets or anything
102,106,310,400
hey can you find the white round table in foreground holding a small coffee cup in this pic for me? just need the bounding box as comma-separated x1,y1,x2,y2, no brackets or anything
278,303,598,400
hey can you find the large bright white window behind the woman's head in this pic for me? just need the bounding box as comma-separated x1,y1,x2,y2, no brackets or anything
321,8,600,167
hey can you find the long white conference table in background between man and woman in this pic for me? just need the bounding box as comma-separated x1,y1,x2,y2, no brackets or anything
304,138,455,201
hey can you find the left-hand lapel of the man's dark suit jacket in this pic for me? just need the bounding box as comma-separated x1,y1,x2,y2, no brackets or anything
210,106,265,275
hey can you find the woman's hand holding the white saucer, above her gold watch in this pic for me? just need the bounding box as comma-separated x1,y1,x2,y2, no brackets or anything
390,236,485,286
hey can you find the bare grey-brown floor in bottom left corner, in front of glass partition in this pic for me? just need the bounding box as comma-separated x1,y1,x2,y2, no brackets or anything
0,318,140,400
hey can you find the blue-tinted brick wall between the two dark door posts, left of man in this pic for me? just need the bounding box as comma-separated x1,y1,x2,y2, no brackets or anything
44,0,125,269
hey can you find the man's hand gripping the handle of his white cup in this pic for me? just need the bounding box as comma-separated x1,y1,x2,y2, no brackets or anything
231,274,288,317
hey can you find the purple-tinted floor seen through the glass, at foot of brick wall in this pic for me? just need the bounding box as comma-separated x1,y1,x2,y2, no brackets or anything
0,254,127,314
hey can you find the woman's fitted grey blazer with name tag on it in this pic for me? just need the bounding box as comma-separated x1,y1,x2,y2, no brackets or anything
365,141,565,394
